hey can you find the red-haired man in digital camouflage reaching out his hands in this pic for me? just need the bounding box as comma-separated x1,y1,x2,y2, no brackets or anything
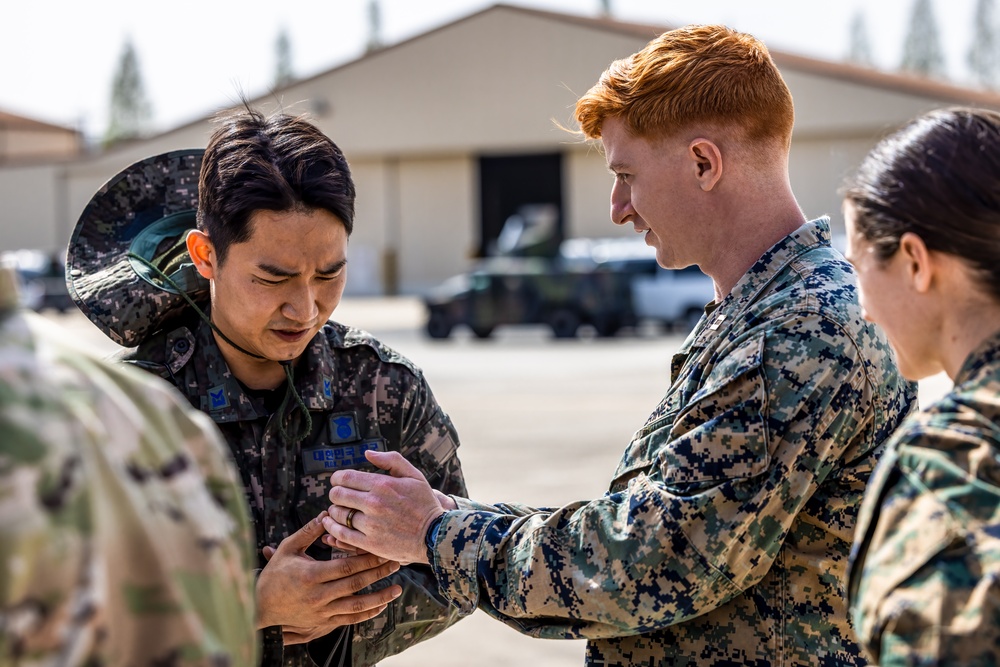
324,26,914,667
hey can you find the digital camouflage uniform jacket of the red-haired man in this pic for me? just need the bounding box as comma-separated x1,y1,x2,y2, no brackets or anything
433,219,914,667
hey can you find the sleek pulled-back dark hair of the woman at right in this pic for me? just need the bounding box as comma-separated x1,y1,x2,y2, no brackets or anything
843,107,1000,298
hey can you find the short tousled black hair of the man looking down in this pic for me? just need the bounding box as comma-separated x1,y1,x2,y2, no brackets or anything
198,106,355,263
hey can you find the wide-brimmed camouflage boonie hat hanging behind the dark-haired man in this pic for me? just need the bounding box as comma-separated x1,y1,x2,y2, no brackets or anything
66,149,209,347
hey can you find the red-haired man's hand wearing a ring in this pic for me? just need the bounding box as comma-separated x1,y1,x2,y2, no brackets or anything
323,451,450,564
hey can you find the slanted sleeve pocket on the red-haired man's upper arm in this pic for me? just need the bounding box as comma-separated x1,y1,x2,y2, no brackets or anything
615,335,770,495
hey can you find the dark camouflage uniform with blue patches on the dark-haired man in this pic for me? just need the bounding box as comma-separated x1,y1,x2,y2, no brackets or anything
122,316,467,667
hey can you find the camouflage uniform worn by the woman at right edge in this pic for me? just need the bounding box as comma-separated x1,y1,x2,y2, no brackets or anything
850,333,1000,666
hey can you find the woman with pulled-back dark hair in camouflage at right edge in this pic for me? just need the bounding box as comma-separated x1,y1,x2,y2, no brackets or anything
844,108,1000,667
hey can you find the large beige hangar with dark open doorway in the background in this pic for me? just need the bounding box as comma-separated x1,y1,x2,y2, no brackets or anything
0,5,1000,294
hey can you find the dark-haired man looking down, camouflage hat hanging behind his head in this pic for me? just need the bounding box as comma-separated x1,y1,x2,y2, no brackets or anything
68,109,465,667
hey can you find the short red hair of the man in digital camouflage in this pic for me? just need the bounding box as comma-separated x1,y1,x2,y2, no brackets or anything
576,25,795,149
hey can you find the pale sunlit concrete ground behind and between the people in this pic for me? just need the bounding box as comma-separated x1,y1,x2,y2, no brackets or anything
52,298,950,667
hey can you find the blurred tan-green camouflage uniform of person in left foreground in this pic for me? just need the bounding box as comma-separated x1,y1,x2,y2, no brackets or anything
0,270,257,667
